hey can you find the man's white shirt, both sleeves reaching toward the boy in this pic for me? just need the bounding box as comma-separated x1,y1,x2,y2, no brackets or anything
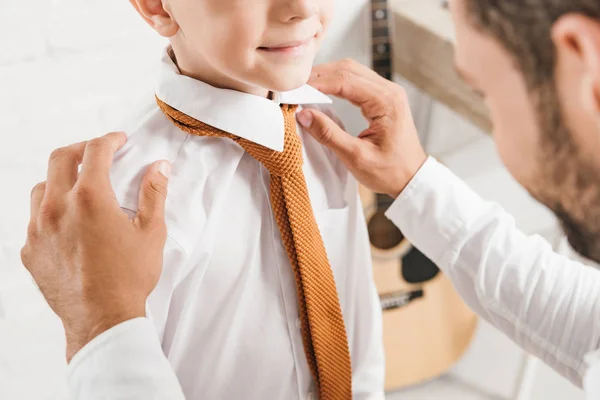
70,158,600,400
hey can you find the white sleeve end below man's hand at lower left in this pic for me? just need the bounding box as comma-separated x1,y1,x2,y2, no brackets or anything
67,318,185,400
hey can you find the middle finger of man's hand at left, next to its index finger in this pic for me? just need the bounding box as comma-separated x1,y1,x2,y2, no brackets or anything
47,142,87,194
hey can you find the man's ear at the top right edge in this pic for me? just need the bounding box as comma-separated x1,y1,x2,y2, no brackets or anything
552,14,600,116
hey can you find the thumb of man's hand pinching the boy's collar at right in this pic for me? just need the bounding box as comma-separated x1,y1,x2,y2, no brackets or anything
297,109,362,160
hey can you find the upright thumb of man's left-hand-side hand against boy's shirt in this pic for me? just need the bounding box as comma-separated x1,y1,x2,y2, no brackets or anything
136,161,171,227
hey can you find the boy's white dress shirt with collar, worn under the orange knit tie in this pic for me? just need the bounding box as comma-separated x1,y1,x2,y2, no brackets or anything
67,50,385,400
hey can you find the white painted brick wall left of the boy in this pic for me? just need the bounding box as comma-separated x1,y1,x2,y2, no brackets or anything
0,0,168,400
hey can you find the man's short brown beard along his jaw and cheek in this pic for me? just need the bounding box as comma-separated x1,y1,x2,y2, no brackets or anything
527,90,600,263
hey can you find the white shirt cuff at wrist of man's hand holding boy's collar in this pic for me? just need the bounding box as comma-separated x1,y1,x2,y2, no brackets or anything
386,157,488,265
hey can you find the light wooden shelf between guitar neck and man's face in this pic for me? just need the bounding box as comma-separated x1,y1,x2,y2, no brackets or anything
390,0,492,133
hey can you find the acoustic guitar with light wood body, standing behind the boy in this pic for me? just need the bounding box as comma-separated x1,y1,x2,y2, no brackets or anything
360,0,477,390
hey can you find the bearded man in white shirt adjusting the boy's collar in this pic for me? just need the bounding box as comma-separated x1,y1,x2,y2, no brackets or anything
23,0,600,399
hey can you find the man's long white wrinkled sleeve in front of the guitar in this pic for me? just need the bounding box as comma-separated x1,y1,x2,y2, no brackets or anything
387,158,600,387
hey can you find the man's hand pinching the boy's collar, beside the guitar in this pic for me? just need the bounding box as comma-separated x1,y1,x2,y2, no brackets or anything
298,60,427,197
